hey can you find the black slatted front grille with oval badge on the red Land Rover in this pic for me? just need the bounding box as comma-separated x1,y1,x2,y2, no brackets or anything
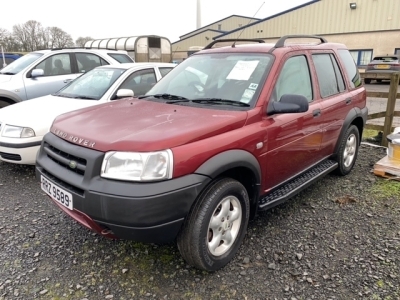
44,142,86,176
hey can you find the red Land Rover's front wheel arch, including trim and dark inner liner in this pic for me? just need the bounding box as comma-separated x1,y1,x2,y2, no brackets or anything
195,150,261,219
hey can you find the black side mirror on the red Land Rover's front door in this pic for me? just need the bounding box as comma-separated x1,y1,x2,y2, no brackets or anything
267,94,308,115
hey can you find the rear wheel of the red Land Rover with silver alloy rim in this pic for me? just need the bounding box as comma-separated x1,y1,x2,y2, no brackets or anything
335,125,360,176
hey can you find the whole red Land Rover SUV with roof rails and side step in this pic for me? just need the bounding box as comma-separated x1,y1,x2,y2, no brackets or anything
36,36,368,271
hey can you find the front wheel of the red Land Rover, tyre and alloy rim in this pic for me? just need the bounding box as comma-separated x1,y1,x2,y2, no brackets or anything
177,178,250,272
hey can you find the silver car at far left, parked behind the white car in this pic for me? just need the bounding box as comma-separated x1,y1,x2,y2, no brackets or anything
0,48,133,108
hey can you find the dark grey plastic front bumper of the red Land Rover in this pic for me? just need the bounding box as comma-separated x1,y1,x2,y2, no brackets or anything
36,133,210,243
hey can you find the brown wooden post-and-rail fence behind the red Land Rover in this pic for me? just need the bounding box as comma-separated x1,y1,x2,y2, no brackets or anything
361,73,400,147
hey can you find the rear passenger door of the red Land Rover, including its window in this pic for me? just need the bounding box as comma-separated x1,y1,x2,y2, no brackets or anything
312,52,353,156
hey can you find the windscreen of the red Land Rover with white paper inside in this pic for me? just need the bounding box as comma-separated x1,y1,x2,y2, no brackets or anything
146,53,272,106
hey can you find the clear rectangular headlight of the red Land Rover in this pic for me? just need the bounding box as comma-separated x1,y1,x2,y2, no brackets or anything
101,149,173,181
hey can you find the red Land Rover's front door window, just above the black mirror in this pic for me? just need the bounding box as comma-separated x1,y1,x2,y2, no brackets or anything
273,55,313,102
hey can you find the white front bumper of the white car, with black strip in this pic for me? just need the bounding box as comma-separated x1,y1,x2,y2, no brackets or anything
0,141,41,165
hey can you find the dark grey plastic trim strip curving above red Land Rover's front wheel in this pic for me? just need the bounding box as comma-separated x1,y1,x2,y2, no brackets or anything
194,150,261,185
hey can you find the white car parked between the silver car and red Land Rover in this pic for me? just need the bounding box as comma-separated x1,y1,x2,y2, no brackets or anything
0,63,176,165
